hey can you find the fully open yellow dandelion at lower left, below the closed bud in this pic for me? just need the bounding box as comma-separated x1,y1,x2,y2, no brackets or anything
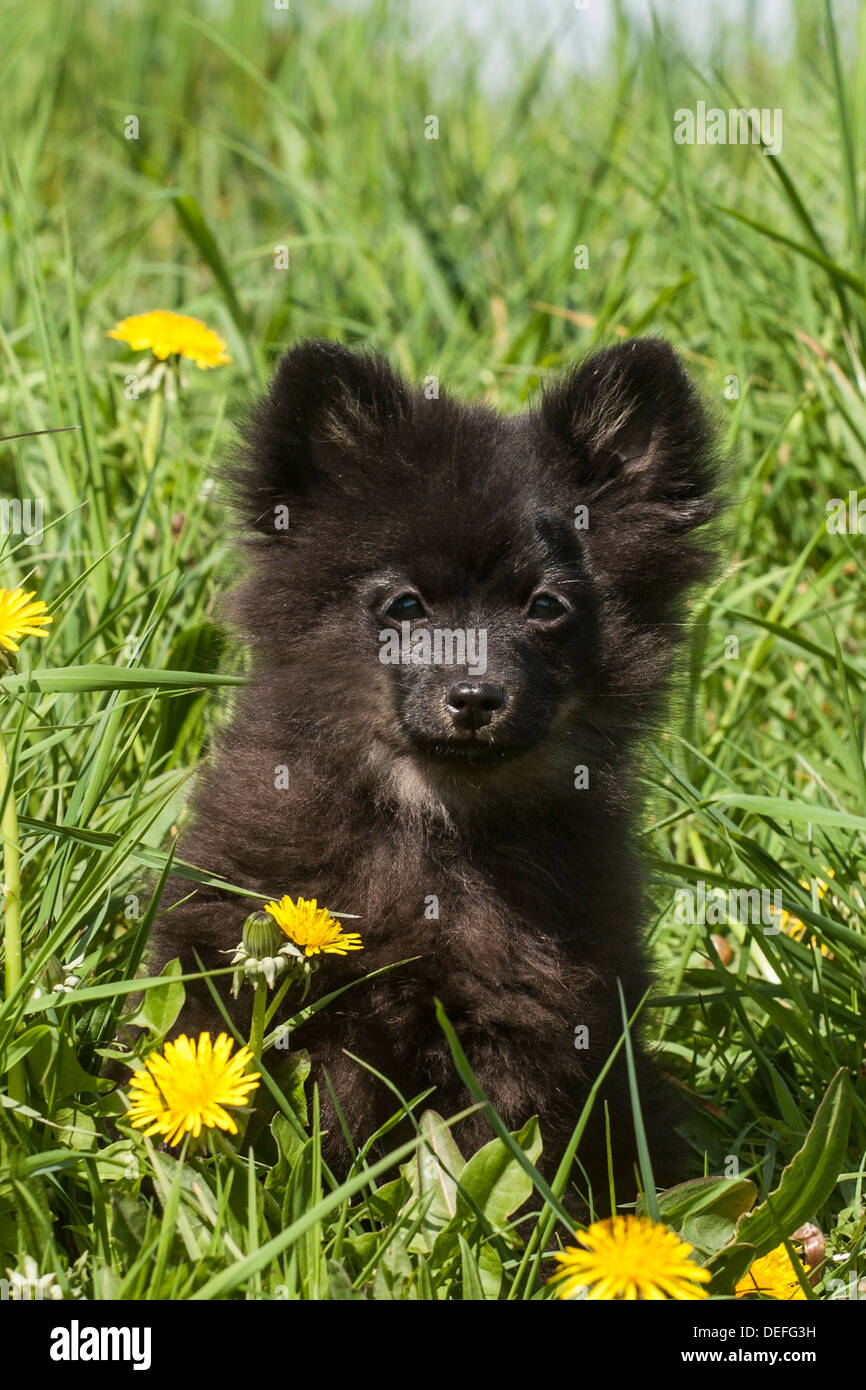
129,1033,261,1145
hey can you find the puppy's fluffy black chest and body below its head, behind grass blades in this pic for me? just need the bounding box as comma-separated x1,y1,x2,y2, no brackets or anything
153,752,646,1166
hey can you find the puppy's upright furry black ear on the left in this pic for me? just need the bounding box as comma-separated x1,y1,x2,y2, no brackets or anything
236,338,411,530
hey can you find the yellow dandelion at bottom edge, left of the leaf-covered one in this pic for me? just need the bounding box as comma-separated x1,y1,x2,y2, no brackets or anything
550,1216,710,1302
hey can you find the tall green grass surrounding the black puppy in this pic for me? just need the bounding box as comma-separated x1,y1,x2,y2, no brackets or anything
0,0,866,1298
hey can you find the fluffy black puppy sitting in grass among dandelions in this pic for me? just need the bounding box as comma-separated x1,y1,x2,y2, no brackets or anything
150,339,714,1195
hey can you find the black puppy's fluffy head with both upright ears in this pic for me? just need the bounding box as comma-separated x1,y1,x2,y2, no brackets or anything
230,339,714,806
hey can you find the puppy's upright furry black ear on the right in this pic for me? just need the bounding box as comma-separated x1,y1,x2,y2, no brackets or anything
541,338,719,616
